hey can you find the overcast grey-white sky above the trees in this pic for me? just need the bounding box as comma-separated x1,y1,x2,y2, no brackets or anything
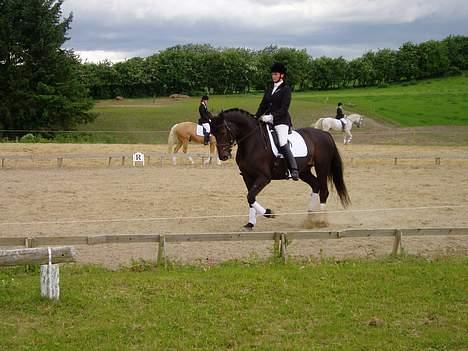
63,0,468,62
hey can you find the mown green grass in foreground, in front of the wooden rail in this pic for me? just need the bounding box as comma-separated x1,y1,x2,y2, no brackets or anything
0,257,468,350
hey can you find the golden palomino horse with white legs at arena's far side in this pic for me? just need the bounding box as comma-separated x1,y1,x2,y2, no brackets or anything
167,122,221,165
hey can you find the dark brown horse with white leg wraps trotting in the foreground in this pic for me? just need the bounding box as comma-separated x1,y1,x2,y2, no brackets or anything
211,109,350,230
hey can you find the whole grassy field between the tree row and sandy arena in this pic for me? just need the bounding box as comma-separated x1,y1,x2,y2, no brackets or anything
72,75,468,143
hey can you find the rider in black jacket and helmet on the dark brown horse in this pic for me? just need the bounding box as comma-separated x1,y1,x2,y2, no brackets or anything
255,63,299,180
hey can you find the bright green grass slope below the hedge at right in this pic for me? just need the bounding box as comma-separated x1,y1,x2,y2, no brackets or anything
296,75,468,127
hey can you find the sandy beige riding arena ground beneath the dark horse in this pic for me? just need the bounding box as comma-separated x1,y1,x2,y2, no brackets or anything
0,143,468,267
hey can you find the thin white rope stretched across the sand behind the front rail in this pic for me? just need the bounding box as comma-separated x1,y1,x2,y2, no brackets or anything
0,205,468,226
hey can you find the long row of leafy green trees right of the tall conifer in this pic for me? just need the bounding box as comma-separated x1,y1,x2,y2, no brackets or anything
81,35,468,99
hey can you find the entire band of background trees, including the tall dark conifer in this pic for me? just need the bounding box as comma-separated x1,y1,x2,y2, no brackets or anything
0,0,468,137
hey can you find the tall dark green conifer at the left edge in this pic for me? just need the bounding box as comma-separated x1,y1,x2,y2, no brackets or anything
0,0,95,130
